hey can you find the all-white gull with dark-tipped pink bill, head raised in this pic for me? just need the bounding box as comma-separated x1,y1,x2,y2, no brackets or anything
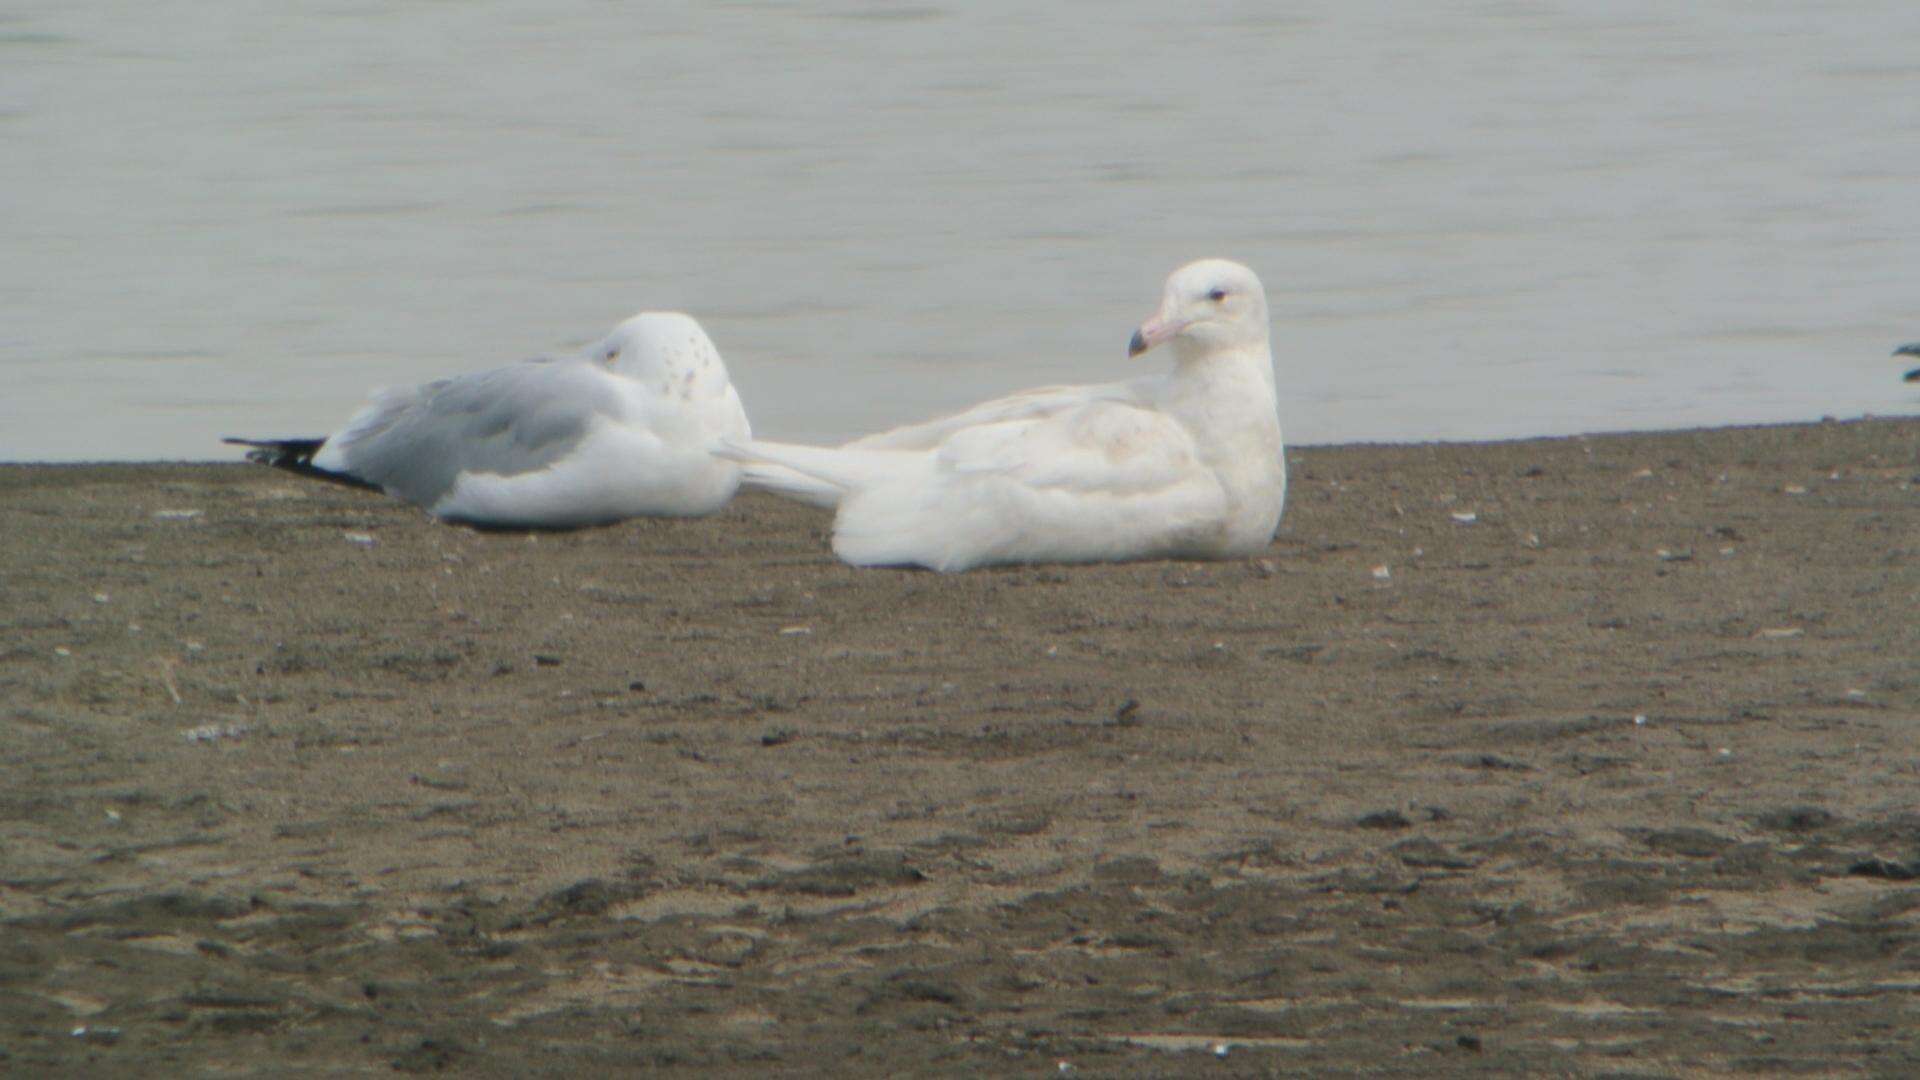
722,259,1286,571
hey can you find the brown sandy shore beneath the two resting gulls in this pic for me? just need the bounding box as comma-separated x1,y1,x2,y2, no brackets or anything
0,419,1920,1076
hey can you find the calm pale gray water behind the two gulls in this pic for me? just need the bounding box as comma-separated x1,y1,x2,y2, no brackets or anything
0,0,1920,459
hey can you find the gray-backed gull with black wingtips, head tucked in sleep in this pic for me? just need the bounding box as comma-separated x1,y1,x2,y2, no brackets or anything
227,311,751,528
